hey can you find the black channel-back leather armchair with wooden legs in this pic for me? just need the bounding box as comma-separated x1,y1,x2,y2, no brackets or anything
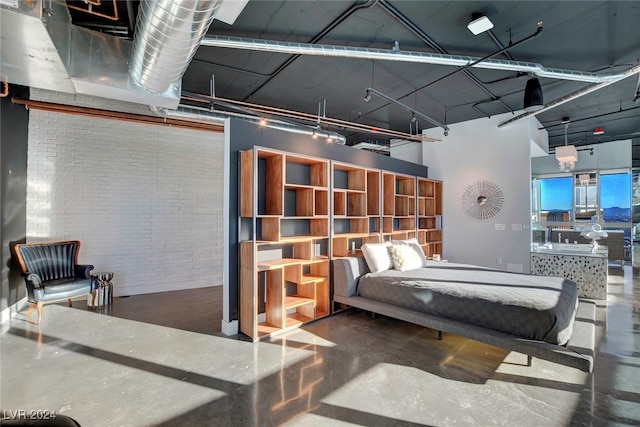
14,240,96,324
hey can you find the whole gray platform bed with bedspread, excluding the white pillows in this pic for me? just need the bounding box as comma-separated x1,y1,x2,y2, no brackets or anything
333,244,596,372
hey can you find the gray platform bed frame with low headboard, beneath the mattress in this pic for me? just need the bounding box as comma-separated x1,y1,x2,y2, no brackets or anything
333,257,596,372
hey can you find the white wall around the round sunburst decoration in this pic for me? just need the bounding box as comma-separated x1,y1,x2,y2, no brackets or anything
423,114,539,273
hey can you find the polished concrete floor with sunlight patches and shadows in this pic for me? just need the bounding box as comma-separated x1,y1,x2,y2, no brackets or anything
0,266,640,427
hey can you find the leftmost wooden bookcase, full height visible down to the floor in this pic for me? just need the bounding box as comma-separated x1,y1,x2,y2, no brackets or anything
240,148,330,341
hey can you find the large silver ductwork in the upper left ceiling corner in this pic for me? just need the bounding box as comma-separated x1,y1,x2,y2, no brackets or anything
0,0,247,108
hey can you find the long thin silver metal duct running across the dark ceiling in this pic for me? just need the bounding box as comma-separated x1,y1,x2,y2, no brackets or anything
201,35,624,83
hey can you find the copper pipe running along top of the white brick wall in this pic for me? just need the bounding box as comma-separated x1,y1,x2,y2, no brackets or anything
11,97,224,132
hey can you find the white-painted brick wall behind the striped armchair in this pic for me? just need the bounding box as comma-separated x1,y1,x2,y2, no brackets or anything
27,91,224,296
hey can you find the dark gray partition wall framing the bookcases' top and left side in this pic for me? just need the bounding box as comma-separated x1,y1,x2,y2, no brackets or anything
229,119,427,320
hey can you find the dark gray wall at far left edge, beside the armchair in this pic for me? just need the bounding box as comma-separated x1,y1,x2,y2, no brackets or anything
0,85,29,321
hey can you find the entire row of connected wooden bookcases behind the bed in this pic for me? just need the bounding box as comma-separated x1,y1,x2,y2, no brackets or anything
239,147,442,341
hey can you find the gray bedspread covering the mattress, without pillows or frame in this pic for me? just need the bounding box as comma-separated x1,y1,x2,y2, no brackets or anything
358,262,578,345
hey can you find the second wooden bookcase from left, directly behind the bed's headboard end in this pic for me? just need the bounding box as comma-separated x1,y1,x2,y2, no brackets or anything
331,162,380,258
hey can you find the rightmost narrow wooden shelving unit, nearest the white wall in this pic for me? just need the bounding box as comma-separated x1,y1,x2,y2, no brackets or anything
417,178,442,257
